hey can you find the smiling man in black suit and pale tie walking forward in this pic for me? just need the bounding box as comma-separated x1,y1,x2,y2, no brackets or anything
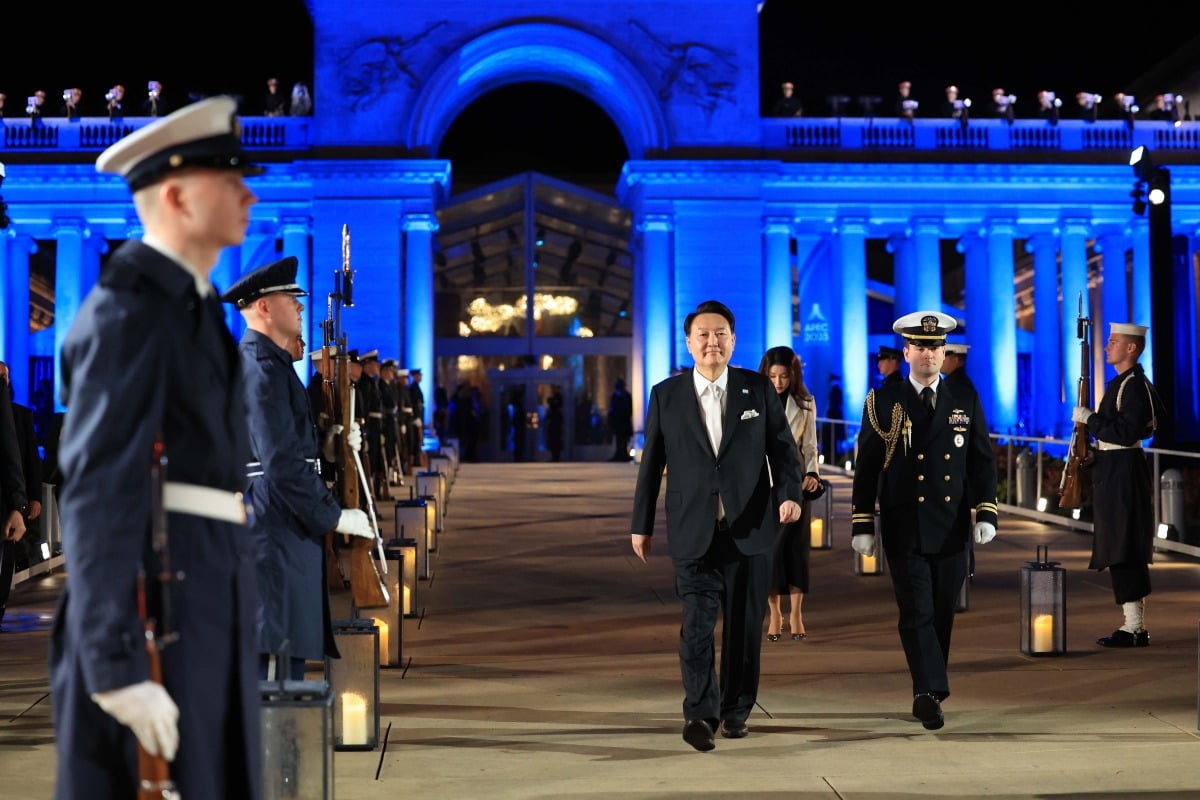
632,300,803,751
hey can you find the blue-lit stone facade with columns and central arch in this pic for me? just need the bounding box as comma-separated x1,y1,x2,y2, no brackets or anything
0,0,1200,450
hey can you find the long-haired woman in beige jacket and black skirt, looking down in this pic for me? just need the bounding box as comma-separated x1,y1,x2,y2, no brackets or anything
758,347,821,642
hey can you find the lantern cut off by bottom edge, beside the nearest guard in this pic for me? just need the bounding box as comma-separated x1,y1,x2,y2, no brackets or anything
258,676,334,800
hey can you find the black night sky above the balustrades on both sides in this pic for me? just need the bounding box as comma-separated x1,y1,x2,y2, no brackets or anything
0,0,1194,172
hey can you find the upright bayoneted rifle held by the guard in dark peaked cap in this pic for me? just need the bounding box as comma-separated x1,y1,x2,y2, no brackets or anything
331,224,388,608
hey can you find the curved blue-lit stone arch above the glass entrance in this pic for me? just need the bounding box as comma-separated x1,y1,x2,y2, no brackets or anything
407,23,667,160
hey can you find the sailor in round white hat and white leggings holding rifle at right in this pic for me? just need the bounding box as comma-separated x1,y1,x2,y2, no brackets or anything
1072,323,1166,648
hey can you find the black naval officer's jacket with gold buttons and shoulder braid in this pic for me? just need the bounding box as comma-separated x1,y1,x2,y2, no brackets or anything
851,379,996,557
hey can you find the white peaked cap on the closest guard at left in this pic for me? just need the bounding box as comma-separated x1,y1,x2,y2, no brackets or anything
96,96,264,192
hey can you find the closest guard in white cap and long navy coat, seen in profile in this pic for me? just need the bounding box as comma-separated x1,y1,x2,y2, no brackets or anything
50,97,265,800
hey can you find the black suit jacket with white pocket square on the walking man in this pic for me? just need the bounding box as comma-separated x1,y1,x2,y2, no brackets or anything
632,367,803,559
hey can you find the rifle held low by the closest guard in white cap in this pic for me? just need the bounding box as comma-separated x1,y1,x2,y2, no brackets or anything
137,438,180,800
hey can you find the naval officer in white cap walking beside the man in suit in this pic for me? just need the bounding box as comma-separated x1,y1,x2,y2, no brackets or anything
851,311,996,730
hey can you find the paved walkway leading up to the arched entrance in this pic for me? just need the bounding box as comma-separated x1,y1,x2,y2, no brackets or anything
0,463,1200,800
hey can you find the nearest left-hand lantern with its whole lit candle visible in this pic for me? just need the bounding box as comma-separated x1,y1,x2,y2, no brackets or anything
325,619,379,750
